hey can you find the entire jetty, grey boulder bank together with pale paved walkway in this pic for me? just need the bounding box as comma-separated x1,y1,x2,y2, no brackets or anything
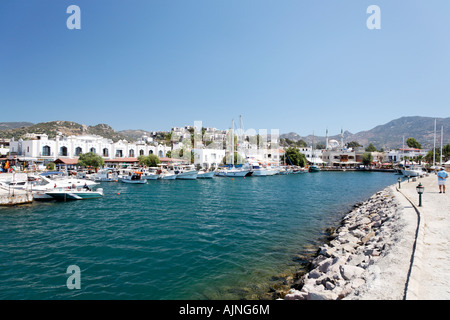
284,174,450,300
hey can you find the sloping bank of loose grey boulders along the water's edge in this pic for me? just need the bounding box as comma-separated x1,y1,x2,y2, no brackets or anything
284,187,403,300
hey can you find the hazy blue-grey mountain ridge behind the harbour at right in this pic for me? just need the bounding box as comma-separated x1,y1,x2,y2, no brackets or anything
280,116,450,150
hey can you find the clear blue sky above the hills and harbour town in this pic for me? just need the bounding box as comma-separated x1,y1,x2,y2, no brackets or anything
0,0,450,135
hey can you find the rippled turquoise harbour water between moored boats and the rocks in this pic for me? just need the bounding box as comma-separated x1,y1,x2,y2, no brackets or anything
0,172,397,300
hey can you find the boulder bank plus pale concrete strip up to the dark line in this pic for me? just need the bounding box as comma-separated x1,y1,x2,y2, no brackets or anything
275,178,418,300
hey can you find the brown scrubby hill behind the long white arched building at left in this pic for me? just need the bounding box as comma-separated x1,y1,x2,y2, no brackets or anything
0,121,131,141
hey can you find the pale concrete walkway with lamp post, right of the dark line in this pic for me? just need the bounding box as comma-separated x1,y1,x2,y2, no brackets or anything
398,174,450,300
